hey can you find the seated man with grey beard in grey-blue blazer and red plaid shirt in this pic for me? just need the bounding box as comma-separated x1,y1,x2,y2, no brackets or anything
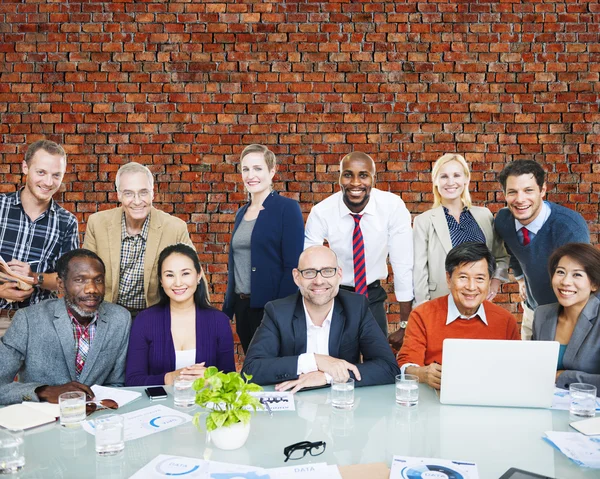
0,249,131,405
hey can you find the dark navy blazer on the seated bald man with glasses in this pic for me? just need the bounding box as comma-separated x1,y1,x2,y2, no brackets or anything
242,289,400,386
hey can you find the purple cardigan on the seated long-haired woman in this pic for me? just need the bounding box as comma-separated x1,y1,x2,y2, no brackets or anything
125,304,235,386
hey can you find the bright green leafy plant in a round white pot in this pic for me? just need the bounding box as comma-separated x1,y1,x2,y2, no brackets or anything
192,366,263,450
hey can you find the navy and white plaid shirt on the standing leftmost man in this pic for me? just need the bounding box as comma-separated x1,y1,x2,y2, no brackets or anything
0,190,79,309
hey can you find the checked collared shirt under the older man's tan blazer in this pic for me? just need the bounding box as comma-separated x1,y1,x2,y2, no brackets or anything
117,213,150,309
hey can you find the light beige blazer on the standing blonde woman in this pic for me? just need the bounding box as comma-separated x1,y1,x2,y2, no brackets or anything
413,206,509,305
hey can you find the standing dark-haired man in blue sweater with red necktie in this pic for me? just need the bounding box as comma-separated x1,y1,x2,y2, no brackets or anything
494,160,590,339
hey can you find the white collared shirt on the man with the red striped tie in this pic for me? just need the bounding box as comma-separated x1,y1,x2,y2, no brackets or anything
304,188,414,301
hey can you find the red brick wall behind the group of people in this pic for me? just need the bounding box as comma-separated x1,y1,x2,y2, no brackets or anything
0,0,600,356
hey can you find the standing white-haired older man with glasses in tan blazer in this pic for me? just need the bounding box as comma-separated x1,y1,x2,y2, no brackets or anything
83,162,194,318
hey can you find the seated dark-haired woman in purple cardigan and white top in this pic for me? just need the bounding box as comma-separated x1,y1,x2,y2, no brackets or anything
125,243,235,386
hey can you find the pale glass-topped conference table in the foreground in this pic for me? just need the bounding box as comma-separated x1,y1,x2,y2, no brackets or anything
12,385,600,479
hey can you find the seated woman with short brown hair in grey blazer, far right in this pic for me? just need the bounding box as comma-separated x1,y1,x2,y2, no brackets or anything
532,243,600,392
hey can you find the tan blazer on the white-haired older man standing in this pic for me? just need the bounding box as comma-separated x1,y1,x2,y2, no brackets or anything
83,206,195,307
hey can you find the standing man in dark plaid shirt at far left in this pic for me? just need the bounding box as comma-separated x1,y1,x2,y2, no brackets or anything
0,140,79,336
